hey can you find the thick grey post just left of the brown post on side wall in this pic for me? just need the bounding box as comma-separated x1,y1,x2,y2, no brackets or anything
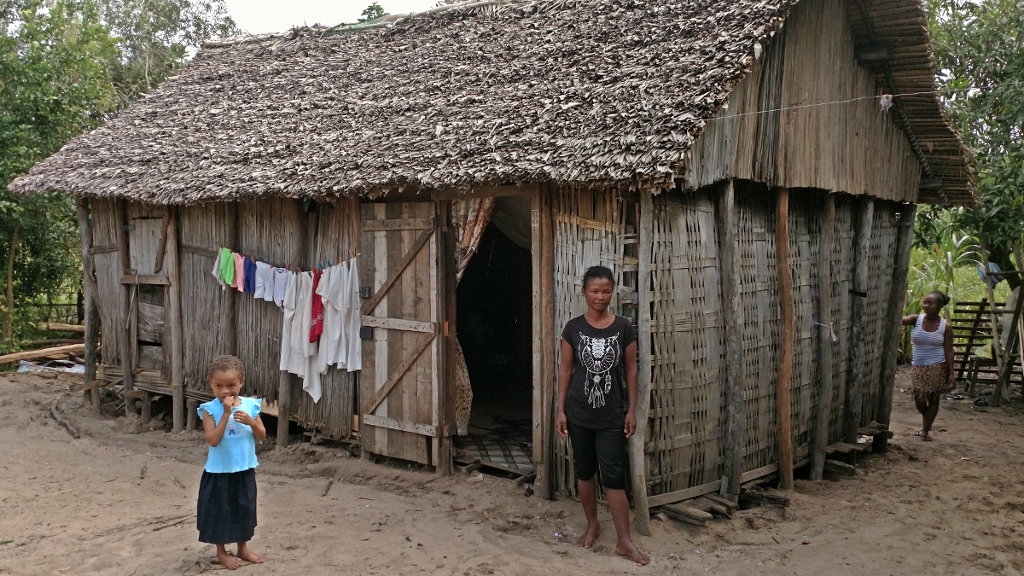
716,179,743,501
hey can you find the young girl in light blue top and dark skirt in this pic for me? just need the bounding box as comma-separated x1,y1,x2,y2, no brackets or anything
196,356,266,570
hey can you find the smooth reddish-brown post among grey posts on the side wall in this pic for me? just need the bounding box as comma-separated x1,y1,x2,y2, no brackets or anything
775,188,794,490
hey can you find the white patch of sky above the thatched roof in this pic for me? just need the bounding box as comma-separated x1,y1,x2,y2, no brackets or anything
224,0,437,34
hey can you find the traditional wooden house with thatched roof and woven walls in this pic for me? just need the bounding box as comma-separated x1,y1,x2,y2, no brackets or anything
10,0,973,529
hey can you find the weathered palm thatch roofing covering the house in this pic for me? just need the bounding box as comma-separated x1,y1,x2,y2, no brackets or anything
10,0,970,204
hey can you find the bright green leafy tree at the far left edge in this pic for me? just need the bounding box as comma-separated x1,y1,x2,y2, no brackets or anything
0,0,118,341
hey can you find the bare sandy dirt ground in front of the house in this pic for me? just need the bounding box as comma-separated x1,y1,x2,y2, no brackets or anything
0,366,1024,576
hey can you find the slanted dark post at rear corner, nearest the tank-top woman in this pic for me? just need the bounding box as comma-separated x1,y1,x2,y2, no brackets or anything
871,204,918,453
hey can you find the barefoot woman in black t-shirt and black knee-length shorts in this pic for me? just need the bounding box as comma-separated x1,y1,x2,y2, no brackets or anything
555,266,650,564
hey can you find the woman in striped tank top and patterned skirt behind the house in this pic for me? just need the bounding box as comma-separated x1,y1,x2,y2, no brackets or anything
903,290,956,441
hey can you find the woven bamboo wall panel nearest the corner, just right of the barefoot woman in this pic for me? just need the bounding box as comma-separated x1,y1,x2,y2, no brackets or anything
641,187,725,494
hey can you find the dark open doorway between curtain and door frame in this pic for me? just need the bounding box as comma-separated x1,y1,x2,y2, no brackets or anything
455,198,534,475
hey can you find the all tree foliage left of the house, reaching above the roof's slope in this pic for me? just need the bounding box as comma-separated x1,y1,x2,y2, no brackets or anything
0,0,240,340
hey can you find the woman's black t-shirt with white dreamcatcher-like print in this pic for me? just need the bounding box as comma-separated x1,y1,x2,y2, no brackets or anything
562,316,637,428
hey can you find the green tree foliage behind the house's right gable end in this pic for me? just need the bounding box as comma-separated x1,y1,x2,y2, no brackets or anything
918,0,1024,285
